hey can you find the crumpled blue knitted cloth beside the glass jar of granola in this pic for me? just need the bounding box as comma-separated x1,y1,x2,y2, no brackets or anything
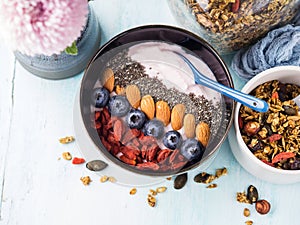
231,21,300,80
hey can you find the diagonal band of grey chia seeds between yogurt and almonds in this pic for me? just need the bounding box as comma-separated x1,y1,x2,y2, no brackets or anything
107,50,223,135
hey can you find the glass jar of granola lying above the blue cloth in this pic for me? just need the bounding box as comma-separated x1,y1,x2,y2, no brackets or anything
168,0,300,54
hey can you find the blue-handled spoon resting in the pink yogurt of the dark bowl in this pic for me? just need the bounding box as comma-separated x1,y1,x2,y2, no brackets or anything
174,52,269,112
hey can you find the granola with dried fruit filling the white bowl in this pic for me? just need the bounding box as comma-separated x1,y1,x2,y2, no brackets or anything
239,80,300,170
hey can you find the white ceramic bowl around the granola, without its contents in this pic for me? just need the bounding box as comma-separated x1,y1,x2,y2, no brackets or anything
231,66,300,184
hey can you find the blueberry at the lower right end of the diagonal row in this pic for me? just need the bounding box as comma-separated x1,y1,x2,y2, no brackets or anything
180,138,205,160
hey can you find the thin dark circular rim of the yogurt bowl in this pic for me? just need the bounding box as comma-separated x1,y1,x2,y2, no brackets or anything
79,24,236,177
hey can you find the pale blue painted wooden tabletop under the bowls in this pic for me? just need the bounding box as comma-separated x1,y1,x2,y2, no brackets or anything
0,0,300,225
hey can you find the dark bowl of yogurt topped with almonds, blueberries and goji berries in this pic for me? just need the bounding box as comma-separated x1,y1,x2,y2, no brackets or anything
79,25,234,176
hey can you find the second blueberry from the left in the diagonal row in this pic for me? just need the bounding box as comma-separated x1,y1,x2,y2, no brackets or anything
108,95,130,117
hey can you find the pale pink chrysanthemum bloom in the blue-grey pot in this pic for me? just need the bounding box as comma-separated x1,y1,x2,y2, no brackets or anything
0,0,88,55
